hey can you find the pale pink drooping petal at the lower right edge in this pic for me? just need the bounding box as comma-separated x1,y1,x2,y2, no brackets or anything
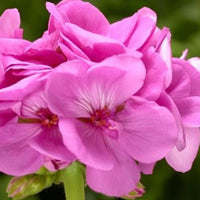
166,128,200,172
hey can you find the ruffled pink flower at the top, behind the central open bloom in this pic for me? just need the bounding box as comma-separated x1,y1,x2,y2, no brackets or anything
43,1,172,101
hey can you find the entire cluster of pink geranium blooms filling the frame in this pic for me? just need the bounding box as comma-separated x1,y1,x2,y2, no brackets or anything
0,0,200,196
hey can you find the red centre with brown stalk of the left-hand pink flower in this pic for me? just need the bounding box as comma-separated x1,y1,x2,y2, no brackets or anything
18,108,58,128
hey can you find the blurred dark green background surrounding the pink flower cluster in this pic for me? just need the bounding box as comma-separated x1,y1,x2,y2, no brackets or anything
0,0,200,200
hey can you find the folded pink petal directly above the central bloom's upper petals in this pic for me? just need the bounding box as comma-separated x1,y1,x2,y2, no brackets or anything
63,23,125,62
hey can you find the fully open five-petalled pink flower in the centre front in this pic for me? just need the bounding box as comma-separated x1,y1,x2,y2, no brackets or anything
46,55,176,196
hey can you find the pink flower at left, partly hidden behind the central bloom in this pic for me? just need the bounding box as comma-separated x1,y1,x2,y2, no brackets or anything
0,81,75,175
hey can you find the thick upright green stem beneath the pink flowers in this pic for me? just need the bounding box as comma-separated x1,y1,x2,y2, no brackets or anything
63,162,85,200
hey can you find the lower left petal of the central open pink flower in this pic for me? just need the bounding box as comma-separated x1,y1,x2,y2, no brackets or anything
59,119,114,170
